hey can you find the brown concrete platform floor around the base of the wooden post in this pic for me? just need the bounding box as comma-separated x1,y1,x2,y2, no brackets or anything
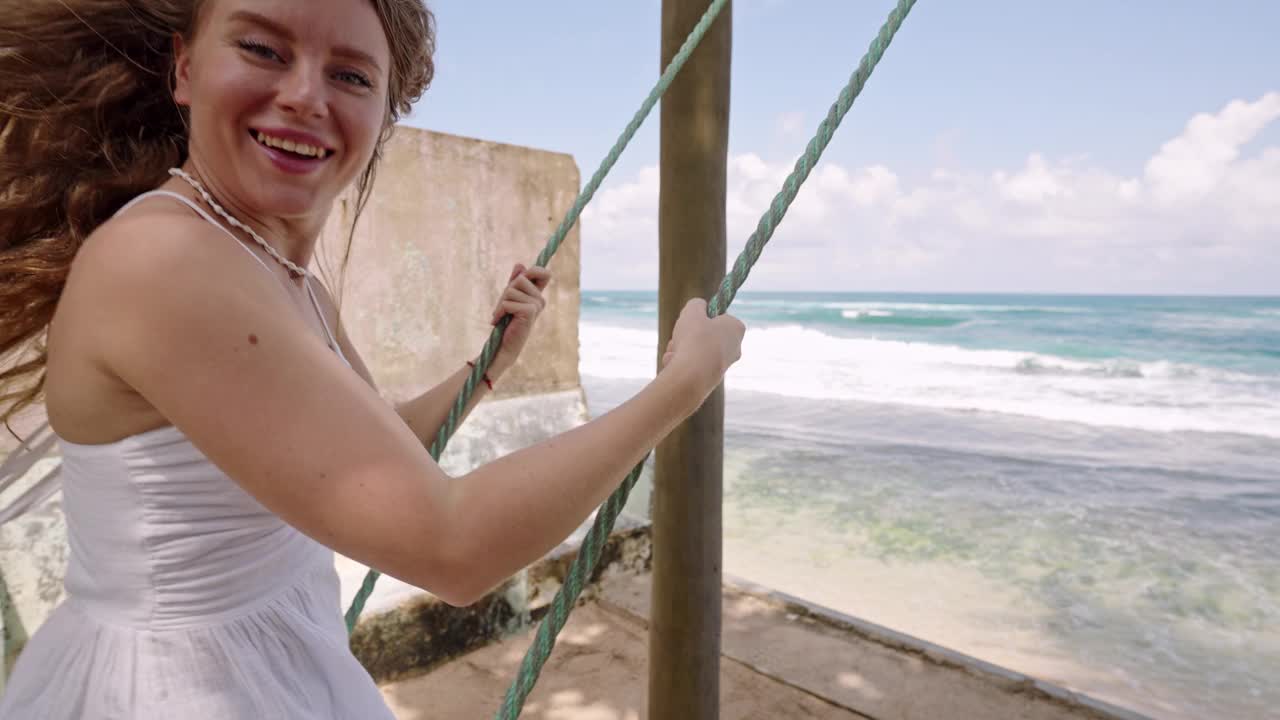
381,574,1139,720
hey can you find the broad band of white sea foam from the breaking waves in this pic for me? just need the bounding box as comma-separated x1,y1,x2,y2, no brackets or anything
580,322,1280,437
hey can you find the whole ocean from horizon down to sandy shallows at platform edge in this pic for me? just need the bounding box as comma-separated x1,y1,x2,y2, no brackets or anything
580,292,1280,719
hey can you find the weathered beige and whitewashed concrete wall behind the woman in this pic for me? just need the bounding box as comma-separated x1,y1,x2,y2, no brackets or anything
0,128,586,682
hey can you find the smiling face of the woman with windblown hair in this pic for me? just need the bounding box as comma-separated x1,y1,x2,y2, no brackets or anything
174,0,390,219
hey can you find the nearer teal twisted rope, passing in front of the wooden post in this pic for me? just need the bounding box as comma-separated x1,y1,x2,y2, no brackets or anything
495,0,915,720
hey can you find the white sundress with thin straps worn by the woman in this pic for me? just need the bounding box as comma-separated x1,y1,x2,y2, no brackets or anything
0,191,393,720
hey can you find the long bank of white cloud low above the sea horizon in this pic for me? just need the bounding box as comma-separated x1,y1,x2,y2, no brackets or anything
582,92,1280,292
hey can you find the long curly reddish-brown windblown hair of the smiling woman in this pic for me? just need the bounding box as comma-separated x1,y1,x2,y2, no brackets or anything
0,0,435,427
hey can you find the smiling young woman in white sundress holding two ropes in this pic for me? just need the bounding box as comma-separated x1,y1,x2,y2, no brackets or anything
0,0,744,720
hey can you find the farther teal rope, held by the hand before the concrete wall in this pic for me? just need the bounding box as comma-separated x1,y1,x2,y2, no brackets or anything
346,0,728,633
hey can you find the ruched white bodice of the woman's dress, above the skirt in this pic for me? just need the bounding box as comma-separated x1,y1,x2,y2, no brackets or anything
59,427,337,629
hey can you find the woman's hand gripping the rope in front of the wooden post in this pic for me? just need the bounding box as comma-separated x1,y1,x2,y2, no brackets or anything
662,297,746,393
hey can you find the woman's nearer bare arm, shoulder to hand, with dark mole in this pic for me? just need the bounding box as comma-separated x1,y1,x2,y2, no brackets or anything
82,218,742,605
